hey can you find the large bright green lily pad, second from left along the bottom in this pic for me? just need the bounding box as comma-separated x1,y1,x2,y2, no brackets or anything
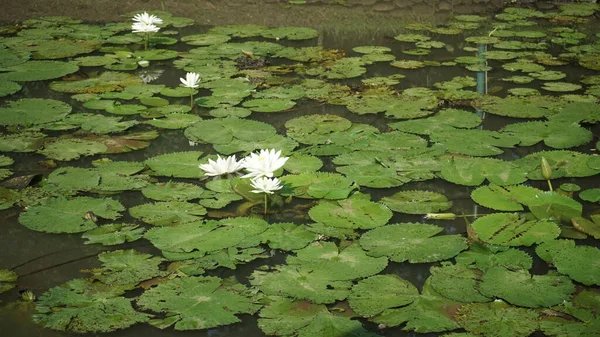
136,276,260,330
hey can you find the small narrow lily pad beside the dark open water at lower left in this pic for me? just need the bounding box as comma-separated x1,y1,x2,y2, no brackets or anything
81,223,146,246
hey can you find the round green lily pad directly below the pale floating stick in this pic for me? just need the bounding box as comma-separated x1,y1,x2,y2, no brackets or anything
360,223,467,263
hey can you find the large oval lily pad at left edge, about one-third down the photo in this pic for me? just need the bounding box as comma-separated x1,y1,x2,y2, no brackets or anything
0,98,72,126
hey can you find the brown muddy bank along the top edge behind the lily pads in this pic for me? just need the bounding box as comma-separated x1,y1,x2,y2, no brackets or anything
0,0,524,28
